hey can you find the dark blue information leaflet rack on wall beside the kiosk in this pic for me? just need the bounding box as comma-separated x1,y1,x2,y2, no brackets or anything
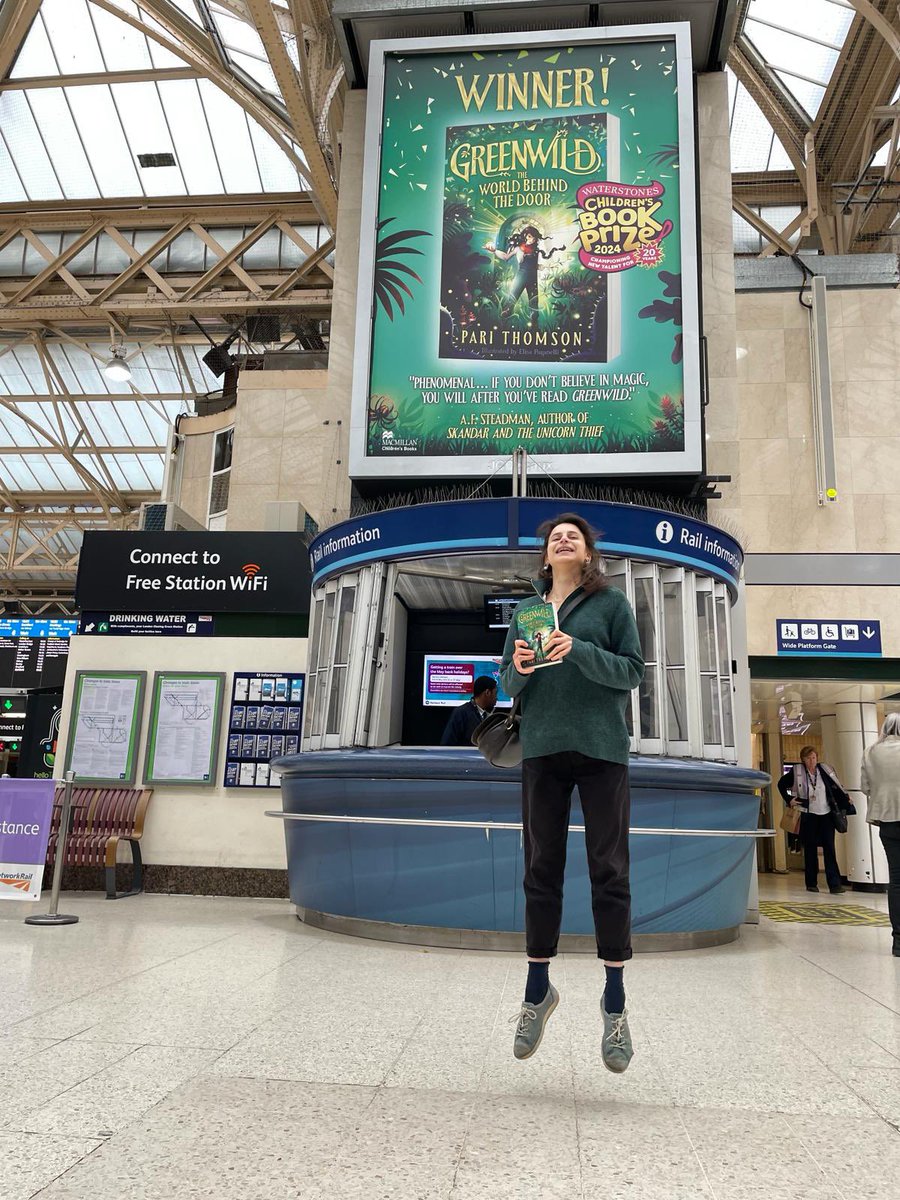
224,671,306,787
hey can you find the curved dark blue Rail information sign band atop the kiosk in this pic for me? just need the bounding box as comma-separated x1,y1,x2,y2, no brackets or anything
310,497,744,593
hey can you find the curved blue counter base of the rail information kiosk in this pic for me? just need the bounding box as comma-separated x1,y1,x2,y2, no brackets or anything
274,748,768,949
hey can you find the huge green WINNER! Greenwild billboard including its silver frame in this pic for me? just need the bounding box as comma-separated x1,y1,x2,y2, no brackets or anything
352,25,701,476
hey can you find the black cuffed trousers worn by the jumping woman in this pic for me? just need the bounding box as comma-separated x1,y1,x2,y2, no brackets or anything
522,750,631,962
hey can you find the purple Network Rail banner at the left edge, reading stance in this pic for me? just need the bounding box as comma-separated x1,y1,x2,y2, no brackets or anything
0,779,56,900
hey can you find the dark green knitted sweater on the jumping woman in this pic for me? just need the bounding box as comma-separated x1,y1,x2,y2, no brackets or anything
500,587,643,763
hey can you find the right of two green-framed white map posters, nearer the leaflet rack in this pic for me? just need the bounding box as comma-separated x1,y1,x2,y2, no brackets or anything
144,671,226,787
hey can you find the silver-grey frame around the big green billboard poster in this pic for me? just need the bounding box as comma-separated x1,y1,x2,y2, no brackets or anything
349,22,703,479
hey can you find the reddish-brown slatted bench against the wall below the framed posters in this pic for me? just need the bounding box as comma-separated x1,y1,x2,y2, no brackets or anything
47,784,154,900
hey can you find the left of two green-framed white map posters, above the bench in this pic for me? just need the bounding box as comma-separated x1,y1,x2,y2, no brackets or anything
65,671,146,784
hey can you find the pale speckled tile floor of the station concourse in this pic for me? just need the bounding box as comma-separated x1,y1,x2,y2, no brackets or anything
0,876,900,1200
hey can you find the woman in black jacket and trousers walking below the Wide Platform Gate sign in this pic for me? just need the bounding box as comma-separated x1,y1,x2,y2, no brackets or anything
778,746,852,895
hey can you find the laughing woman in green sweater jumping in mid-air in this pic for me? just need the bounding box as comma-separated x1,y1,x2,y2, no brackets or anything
500,512,643,1072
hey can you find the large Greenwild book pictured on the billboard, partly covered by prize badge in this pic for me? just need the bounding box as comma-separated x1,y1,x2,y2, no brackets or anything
439,113,619,364
